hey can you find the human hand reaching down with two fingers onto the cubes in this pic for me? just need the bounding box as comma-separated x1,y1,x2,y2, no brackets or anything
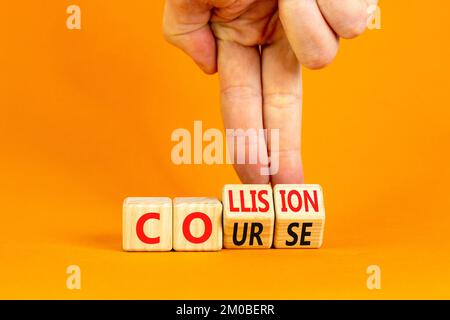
164,0,377,185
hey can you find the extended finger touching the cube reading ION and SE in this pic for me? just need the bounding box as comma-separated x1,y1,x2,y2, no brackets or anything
262,37,304,185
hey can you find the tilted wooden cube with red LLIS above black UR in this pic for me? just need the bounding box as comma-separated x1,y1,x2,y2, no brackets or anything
222,185,275,249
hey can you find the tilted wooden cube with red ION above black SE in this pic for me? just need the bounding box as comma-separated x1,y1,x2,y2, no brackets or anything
273,184,325,249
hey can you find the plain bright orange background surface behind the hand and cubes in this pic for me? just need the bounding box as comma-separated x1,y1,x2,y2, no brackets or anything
0,0,450,299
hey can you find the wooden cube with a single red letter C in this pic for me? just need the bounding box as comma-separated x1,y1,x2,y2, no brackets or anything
122,198,172,251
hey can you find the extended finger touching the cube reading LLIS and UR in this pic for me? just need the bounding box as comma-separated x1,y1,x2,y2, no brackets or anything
218,40,269,184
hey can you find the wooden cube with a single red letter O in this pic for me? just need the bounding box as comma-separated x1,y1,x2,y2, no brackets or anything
173,198,222,251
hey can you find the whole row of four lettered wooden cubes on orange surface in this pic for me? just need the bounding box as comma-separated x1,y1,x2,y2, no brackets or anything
123,184,325,251
